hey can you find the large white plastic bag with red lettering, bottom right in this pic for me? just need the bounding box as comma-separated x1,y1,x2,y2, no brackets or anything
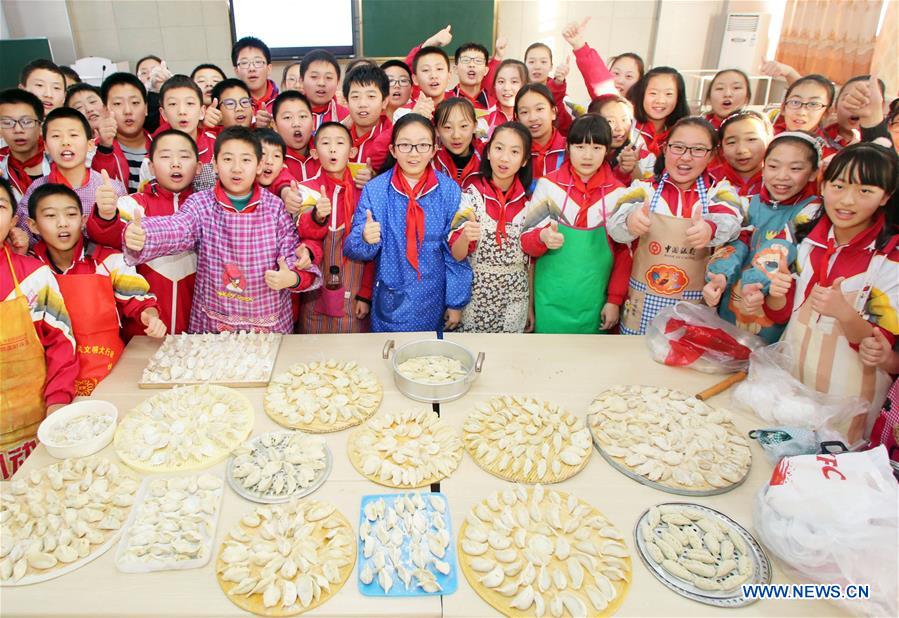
753,446,899,616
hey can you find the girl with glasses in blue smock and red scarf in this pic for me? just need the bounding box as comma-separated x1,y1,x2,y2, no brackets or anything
344,113,472,332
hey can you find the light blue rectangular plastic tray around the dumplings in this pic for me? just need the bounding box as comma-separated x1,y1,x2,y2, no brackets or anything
356,491,459,597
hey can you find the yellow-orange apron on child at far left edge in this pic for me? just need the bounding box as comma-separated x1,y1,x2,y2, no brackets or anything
0,247,47,479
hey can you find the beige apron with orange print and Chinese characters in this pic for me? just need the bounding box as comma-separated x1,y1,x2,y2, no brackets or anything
621,212,709,335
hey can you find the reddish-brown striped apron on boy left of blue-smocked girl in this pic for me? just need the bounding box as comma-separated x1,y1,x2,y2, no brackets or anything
300,215,370,334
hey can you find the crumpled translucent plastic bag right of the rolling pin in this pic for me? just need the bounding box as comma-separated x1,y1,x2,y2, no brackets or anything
733,341,868,439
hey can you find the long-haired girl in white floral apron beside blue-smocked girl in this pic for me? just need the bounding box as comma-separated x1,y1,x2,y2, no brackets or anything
449,122,533,333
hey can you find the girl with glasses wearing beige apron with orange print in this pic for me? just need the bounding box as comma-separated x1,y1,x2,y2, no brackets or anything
608,116,743,335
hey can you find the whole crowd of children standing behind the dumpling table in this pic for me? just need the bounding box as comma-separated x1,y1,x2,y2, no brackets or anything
0,20,899,476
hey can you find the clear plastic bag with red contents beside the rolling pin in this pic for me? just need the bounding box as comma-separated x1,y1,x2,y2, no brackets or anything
646,302,765,373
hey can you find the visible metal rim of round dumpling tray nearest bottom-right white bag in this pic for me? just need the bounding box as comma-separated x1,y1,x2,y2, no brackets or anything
634,502,771,607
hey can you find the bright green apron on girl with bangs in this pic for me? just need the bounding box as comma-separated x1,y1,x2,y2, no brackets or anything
534,223,614,335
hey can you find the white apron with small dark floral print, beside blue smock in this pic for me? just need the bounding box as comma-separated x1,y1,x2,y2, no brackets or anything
462,188,530,333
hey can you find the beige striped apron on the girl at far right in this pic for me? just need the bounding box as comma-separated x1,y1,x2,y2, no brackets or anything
784,254,890,443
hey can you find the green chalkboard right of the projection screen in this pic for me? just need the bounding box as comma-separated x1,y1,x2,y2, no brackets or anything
362,0,495,58
